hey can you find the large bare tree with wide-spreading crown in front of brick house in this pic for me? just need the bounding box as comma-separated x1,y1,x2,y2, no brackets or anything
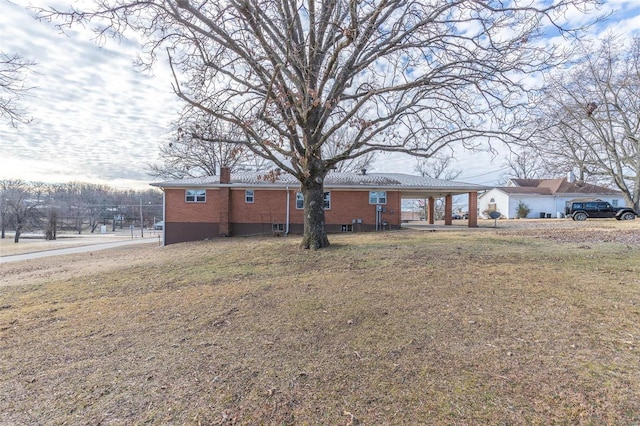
47,0,595,248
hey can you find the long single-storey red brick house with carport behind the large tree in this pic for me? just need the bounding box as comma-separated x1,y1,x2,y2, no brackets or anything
151,168,488,244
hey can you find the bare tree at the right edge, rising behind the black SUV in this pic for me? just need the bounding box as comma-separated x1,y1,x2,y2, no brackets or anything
531,36,640,210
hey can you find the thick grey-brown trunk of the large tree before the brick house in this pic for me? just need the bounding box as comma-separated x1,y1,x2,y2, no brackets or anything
300,177,329,250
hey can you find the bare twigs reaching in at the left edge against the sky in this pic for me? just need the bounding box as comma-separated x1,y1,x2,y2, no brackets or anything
0,52,35,127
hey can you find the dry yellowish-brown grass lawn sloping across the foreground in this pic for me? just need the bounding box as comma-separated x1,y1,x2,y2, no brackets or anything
0,225,640,425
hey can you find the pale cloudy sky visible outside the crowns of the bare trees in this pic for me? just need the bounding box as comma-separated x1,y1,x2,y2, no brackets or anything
0,0,640,188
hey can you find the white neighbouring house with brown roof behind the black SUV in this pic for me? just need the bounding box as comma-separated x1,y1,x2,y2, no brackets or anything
478,176,625,219
